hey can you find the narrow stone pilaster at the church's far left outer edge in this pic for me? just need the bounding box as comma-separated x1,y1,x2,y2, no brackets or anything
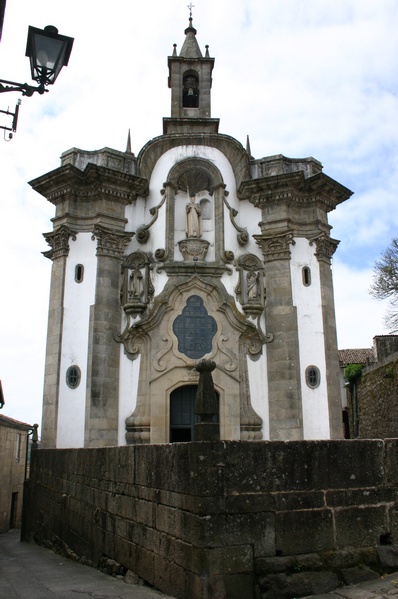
41,227,76,449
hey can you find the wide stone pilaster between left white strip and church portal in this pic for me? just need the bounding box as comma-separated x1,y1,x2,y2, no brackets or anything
85,227,132,447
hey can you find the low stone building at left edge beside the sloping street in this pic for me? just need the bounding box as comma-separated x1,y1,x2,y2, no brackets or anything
0,414,32,533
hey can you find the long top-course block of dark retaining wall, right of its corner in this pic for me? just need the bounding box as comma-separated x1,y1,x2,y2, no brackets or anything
225,441,384,493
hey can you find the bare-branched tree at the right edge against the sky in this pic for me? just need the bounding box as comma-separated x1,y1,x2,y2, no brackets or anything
369,237,398,333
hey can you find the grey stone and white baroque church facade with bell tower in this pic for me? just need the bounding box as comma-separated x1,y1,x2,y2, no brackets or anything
30,19,351,447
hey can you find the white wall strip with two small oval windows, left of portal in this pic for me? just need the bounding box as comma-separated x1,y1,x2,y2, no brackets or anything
57,233,96,447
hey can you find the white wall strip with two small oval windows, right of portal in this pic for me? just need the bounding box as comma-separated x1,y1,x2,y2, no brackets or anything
290,238,330,439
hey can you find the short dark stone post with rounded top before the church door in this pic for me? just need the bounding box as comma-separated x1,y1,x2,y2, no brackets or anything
195,359,220,441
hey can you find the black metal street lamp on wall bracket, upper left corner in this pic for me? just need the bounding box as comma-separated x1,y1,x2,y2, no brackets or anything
0,25,74,139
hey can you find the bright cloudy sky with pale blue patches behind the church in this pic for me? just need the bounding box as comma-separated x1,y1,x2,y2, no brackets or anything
0,0,398,432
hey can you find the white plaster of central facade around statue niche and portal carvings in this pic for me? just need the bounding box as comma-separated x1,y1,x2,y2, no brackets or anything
119,146,269,444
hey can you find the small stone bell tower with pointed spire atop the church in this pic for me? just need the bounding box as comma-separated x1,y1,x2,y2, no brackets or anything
163,12,219,134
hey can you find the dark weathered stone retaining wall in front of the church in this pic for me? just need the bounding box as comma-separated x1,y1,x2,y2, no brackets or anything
23,439,398,599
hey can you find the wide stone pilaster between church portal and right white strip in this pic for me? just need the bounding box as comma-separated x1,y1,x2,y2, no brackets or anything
255,234,303,441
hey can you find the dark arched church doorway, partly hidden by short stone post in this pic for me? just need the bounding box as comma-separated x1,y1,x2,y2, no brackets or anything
170,385,198,443
